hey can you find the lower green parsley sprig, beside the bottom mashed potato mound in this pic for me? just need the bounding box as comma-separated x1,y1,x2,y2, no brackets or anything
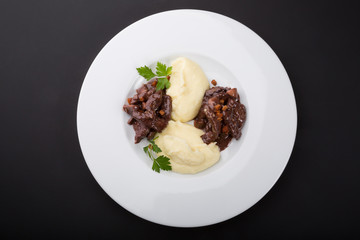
144,137,171,173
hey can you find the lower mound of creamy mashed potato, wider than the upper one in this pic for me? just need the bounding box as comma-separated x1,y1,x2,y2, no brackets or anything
155,121,220,173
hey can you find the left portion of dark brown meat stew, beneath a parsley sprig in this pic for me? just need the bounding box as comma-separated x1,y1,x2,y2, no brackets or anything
123,79,172,143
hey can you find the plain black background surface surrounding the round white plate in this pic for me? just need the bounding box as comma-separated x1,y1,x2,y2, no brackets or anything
0,0,360,239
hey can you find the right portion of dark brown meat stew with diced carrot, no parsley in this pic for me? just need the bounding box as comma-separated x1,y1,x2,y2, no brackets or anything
194,86,246,151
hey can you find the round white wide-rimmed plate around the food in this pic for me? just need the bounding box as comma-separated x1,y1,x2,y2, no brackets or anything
77,10,297,227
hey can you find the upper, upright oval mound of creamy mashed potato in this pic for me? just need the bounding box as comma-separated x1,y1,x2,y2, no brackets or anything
166,57,209,122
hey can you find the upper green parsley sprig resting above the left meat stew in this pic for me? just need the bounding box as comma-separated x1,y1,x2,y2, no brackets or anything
136,62,172,90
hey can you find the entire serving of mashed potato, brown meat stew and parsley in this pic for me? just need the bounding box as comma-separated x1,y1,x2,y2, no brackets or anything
123,57,246,173
